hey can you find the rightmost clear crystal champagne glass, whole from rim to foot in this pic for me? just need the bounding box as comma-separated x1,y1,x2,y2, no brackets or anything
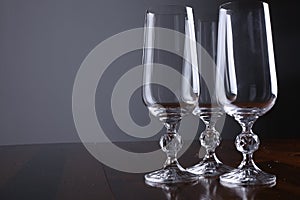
216,1,278,185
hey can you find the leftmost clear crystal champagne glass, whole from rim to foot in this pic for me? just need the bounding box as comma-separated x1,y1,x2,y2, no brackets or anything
142,5,199,184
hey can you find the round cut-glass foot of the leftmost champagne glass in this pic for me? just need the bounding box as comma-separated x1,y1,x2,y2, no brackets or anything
144,166,199,184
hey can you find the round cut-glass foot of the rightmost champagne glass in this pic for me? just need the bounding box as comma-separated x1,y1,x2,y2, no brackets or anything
220,168,276,186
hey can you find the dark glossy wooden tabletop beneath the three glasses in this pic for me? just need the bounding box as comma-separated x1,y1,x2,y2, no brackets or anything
0,139,300,200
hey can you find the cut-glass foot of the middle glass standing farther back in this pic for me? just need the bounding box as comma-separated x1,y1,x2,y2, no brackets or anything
187,160,233,177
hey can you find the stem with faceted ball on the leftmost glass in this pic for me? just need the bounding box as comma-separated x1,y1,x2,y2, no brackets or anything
160,121,183,168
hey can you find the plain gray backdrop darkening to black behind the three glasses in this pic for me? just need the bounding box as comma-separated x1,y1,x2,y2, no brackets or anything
0,0,300,145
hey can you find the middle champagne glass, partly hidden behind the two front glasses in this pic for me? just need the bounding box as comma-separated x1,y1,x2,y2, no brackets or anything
187,20,232,177
